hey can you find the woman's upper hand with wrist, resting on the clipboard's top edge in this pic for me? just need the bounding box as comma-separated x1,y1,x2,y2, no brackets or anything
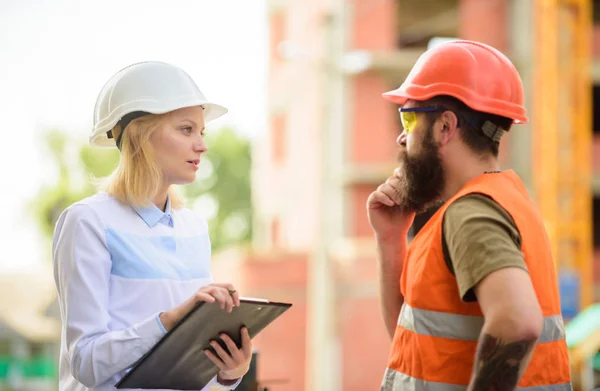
159,284,240,331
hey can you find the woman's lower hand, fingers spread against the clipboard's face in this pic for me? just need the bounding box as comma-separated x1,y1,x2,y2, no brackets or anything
204,327,252,385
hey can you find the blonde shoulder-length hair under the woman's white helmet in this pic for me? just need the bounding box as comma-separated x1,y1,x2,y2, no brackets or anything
99,113,184,209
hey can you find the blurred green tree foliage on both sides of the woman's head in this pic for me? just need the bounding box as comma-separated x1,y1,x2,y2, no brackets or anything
32,128,252,251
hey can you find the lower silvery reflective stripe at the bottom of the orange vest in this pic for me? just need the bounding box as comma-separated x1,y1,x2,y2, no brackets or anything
381,368,573,391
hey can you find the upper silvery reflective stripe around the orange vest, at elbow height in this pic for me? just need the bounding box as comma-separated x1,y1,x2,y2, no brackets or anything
398,303,565,343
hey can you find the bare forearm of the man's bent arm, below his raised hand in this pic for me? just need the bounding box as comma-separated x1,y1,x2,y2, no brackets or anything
377,239,407,338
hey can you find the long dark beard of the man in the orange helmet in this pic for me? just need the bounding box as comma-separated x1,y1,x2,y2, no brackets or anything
398,128,445,213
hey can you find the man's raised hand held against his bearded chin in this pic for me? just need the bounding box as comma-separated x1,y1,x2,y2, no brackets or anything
367,168,415,242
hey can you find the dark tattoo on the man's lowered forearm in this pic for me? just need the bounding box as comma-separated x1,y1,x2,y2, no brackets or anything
469,334,536,391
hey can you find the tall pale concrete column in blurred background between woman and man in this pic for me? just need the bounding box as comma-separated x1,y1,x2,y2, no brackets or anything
305,0,346,391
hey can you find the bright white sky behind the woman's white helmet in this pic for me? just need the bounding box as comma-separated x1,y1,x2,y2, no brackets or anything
0,0,268,272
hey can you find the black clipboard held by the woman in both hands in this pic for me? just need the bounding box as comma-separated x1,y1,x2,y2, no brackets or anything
115,298,292,391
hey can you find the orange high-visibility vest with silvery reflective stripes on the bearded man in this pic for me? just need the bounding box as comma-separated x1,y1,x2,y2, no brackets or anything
382,171,572,391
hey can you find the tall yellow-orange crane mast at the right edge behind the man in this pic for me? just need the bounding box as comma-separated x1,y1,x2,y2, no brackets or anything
532,0,600,390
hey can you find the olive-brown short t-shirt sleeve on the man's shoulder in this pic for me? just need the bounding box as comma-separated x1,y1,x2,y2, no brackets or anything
443,194,527,302
